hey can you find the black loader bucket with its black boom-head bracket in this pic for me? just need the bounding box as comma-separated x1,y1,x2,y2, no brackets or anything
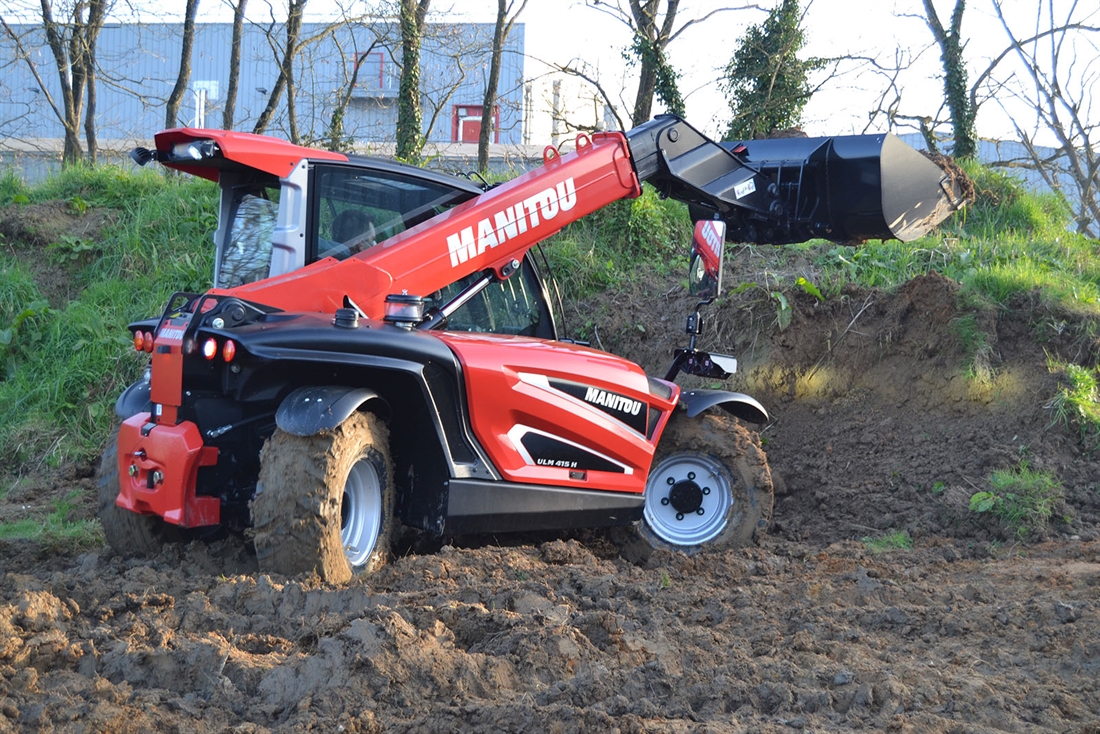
627,116,966,244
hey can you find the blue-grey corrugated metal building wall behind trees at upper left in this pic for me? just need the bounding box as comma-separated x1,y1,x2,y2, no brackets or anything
0,22,524,145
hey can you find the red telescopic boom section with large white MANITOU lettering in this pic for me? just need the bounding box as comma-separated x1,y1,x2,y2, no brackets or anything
215,133,641,318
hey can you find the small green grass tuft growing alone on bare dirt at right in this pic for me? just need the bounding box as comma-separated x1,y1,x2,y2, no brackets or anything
970,461,1065,540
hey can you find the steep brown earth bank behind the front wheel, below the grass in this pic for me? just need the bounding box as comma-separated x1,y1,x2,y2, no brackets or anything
600,268,1100,545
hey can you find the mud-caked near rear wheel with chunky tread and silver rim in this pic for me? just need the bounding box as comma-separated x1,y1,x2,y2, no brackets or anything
252,413,395,583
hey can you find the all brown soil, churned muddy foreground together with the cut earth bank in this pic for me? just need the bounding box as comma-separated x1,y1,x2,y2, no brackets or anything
0,250,1100,734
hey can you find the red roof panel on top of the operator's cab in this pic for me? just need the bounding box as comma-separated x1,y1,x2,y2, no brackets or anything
155,128,348,180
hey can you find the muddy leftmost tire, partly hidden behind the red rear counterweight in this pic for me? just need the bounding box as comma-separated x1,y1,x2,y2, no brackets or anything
96,428,180,557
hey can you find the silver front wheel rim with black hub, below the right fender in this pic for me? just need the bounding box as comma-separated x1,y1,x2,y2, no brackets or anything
645,453,734,546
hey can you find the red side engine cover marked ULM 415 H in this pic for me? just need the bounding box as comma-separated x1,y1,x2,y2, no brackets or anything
439,332,679,494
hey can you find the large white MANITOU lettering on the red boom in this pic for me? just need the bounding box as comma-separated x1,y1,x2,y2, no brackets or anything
447,176,576,267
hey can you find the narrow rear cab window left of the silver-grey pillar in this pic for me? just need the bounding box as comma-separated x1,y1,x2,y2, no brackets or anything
216,186,279,288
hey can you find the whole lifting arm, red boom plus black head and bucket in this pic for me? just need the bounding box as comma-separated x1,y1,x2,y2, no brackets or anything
212,116,958,318
